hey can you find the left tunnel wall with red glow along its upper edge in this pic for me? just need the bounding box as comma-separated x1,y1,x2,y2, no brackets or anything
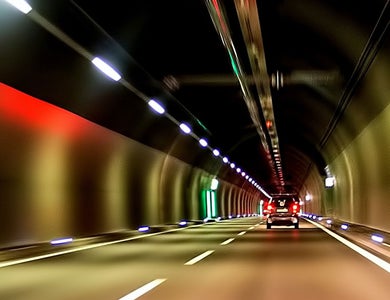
0,84,257,248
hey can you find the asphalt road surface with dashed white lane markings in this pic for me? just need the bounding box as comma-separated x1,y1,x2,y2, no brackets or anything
0,217,390,300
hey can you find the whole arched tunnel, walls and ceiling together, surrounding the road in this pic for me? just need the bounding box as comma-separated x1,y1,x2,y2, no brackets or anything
0,0,390,299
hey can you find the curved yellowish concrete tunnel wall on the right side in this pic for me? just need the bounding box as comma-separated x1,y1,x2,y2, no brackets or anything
301,35,390,231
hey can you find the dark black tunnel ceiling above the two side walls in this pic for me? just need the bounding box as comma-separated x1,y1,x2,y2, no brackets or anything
0,0,388,196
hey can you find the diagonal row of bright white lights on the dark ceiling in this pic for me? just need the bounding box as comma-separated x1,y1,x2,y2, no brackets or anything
6,0,270,197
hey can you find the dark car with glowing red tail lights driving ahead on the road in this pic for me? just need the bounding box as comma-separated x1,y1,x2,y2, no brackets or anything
267,195,300,229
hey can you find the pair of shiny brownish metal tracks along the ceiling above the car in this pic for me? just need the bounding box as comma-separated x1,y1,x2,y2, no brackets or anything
206,0,285,190
